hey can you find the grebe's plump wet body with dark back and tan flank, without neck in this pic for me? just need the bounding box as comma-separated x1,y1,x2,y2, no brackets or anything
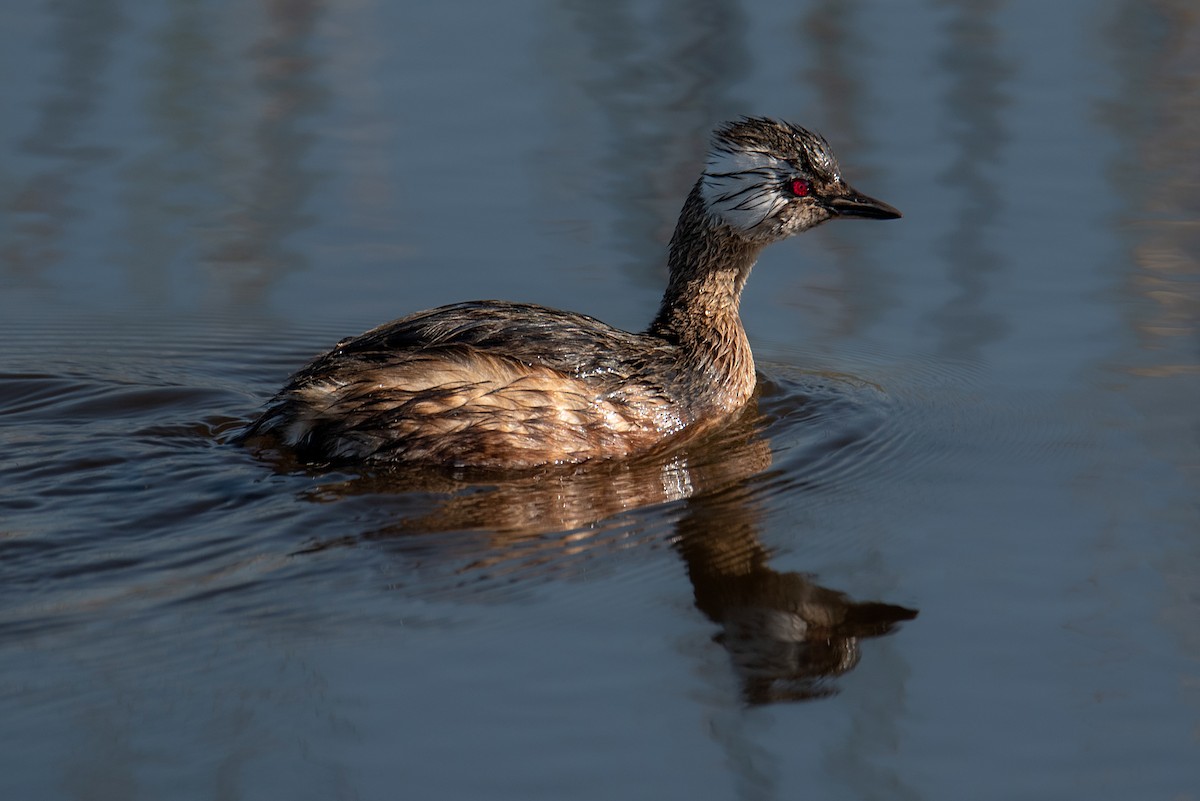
247,301,690,466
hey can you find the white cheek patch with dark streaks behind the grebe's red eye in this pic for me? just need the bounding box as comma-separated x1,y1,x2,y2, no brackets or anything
701,149,791,230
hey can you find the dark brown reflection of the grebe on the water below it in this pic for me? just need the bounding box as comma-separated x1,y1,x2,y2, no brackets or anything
243,377,917,705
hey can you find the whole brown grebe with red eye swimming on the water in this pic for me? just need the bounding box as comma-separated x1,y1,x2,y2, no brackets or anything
242,118,900,468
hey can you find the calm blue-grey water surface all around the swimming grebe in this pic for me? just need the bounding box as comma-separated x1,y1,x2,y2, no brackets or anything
0,0,1200,800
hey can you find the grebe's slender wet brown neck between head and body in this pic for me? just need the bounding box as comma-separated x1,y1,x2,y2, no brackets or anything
649,182,762,408
